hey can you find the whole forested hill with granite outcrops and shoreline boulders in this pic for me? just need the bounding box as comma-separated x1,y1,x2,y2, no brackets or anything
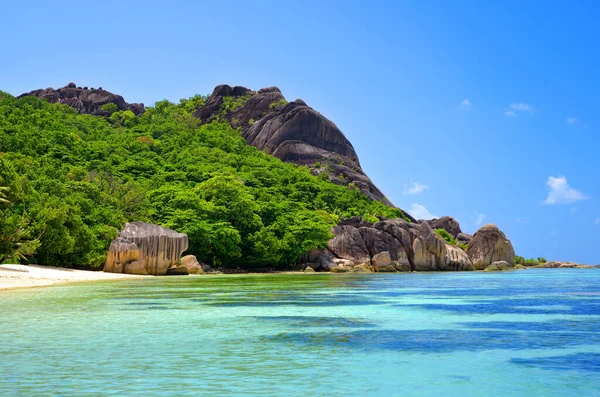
0,83,592,275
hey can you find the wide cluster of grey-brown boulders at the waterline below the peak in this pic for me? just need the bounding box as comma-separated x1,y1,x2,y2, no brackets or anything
307,217,473,272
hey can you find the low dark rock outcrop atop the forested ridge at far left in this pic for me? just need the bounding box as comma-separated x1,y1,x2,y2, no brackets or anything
19,83,145,117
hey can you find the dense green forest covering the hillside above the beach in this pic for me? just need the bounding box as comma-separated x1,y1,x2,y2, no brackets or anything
0,92,404,269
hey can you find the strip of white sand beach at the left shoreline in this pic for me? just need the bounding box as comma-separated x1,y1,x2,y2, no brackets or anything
0,265,149,291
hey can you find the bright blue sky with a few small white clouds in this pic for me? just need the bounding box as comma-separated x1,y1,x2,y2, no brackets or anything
0,0,600,264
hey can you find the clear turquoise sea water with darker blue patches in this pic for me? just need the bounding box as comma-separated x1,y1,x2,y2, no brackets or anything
0,269,600,397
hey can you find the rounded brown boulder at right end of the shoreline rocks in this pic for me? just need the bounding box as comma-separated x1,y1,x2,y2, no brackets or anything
467,224,515,270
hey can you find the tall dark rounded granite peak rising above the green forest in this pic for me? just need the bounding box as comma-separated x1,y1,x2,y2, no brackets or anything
194,85,392,205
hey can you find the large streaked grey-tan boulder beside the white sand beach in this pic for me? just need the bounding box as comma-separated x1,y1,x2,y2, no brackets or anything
104,222,188,276
